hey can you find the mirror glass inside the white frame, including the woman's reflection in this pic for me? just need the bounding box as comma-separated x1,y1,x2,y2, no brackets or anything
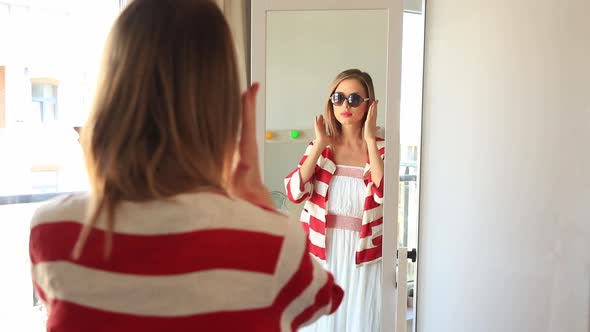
264,9,388,331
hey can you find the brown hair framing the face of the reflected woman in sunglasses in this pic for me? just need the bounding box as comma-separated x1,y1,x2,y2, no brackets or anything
326,69,375,139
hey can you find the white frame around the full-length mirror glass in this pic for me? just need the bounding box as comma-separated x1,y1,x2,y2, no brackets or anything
251,0,405,332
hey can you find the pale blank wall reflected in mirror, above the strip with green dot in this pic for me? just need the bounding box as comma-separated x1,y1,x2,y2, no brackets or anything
266,10,387,130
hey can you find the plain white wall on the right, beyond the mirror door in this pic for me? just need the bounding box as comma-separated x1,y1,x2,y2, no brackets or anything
418,0,590,332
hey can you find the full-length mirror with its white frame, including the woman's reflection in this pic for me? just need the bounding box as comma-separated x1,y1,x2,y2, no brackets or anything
252,1,405,332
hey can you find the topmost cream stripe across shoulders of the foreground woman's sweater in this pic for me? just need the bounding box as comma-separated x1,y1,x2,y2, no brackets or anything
31,193,300,241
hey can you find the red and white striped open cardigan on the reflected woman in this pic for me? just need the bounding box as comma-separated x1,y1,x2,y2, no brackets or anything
285,138,385,265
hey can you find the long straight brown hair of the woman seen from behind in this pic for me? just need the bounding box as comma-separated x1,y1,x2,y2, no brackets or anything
74,0,241,257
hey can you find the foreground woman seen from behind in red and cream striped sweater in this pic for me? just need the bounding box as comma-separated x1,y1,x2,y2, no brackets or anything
30,0,343,331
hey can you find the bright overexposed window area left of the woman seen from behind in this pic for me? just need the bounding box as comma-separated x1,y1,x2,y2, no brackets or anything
0,0,120,331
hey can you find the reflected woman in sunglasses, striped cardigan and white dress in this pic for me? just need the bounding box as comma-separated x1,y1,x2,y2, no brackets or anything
285,69,385,332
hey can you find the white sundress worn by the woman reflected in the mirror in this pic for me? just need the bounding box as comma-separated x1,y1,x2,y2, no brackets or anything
300,165,382,332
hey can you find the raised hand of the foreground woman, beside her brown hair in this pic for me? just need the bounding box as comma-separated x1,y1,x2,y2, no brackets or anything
228,83,273,208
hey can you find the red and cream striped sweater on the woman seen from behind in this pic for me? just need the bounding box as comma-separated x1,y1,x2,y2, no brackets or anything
30,193,343,331
